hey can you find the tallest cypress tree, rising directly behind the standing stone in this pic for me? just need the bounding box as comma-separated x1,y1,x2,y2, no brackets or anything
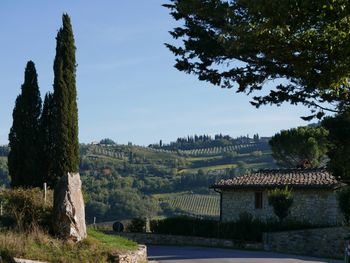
53,14,79,186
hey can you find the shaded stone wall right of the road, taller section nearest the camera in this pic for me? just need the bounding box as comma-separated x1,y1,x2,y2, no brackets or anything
263,227,350,258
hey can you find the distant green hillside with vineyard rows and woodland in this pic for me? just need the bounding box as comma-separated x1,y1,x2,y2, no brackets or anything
0,138,275,222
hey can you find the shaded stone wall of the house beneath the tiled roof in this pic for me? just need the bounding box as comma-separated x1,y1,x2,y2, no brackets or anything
221,190,342,225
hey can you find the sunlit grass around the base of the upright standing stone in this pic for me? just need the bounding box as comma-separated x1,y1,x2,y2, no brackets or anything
0,228,137,263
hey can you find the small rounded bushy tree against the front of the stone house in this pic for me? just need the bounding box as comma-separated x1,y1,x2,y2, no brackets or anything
268,187,293,222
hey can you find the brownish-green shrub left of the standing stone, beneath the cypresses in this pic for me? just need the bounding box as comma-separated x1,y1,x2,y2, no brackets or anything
0,188,53,230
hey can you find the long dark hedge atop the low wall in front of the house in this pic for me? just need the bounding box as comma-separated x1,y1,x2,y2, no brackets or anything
150,216,321,242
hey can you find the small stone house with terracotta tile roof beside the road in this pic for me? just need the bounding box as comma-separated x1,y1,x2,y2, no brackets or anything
211,169,342,225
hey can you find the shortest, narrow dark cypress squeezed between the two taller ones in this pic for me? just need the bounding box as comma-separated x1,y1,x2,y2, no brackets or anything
40,93,55,188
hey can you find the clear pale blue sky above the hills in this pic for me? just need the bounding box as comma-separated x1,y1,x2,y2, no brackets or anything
0,0,308,145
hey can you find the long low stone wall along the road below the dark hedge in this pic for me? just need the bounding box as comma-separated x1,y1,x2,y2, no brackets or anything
113,233,263,249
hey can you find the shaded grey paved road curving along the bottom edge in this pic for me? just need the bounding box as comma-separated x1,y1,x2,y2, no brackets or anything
147,246,342,263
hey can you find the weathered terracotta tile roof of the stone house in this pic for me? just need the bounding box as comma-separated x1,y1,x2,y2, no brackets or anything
211,169,341,189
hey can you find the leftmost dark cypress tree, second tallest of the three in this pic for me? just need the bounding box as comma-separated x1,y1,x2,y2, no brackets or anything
8,61,41,190
